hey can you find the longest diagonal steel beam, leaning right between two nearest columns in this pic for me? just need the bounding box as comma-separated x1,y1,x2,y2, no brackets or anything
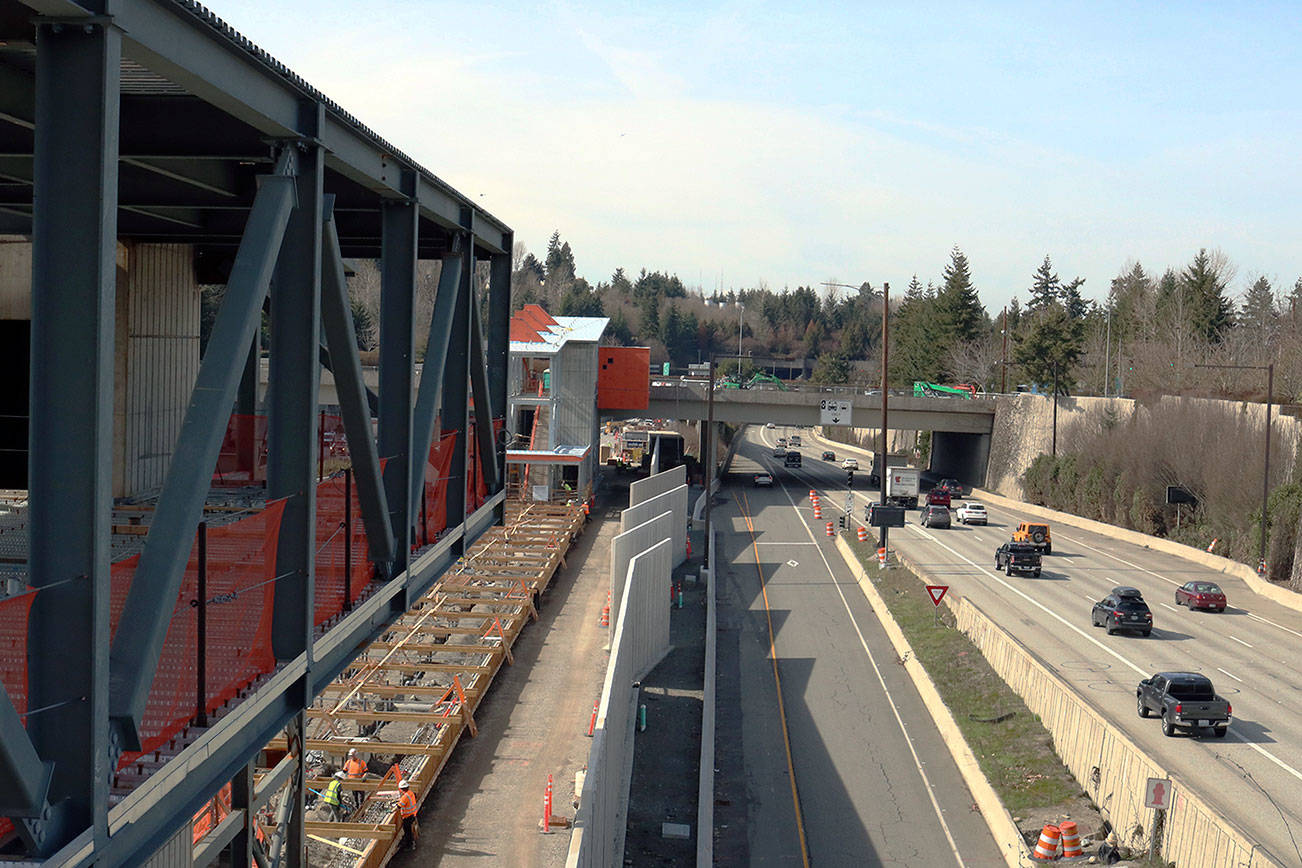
108,150,298,750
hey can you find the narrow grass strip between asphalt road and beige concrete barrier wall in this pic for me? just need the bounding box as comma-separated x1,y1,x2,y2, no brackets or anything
850,541,1085,816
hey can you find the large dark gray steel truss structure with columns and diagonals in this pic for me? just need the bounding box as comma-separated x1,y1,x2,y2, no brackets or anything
0,0,512,865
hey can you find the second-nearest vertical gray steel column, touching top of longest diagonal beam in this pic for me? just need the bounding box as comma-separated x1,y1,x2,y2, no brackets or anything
267,125,324,671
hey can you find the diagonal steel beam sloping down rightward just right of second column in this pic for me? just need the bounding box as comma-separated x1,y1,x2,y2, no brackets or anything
322,197,393,571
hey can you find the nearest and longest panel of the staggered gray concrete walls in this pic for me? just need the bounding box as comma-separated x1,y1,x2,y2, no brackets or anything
565,540,673,868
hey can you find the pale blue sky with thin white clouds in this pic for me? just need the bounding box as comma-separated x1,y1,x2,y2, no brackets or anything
210,0,1302,312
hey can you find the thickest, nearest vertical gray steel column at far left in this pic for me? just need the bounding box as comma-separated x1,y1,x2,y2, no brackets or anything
27,20,121,854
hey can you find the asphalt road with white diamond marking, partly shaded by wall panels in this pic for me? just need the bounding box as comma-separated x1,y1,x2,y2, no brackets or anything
715,435,1003,865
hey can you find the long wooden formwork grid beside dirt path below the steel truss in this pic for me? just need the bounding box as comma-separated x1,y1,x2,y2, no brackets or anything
249,500,586,868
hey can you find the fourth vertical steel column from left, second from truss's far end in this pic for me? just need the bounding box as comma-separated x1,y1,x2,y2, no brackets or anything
440,208,475,546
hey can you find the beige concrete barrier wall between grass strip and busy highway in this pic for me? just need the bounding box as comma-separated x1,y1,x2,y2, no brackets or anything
957,597,1281,868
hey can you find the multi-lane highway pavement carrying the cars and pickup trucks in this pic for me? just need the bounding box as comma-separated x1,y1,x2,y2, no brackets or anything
747,427,1302,865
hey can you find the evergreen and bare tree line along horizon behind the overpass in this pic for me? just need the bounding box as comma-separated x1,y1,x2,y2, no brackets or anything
512,232,1302,400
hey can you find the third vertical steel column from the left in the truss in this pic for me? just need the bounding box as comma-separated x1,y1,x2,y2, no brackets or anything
380,191,421,575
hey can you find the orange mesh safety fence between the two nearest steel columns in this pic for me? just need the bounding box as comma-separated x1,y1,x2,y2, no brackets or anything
109,500,285,768
